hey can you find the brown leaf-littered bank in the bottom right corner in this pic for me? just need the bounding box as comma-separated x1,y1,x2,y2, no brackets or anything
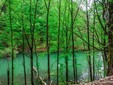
78,75,113,85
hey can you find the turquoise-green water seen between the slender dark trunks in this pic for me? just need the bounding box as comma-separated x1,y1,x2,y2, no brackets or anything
0,52,103,85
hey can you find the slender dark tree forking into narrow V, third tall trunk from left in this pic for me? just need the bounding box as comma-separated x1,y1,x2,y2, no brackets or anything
29,0,38,85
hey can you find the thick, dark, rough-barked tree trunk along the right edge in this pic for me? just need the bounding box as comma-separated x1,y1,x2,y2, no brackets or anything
107,1,113,75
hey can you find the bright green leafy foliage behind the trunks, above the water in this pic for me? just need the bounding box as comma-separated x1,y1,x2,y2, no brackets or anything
0,0,107,52
